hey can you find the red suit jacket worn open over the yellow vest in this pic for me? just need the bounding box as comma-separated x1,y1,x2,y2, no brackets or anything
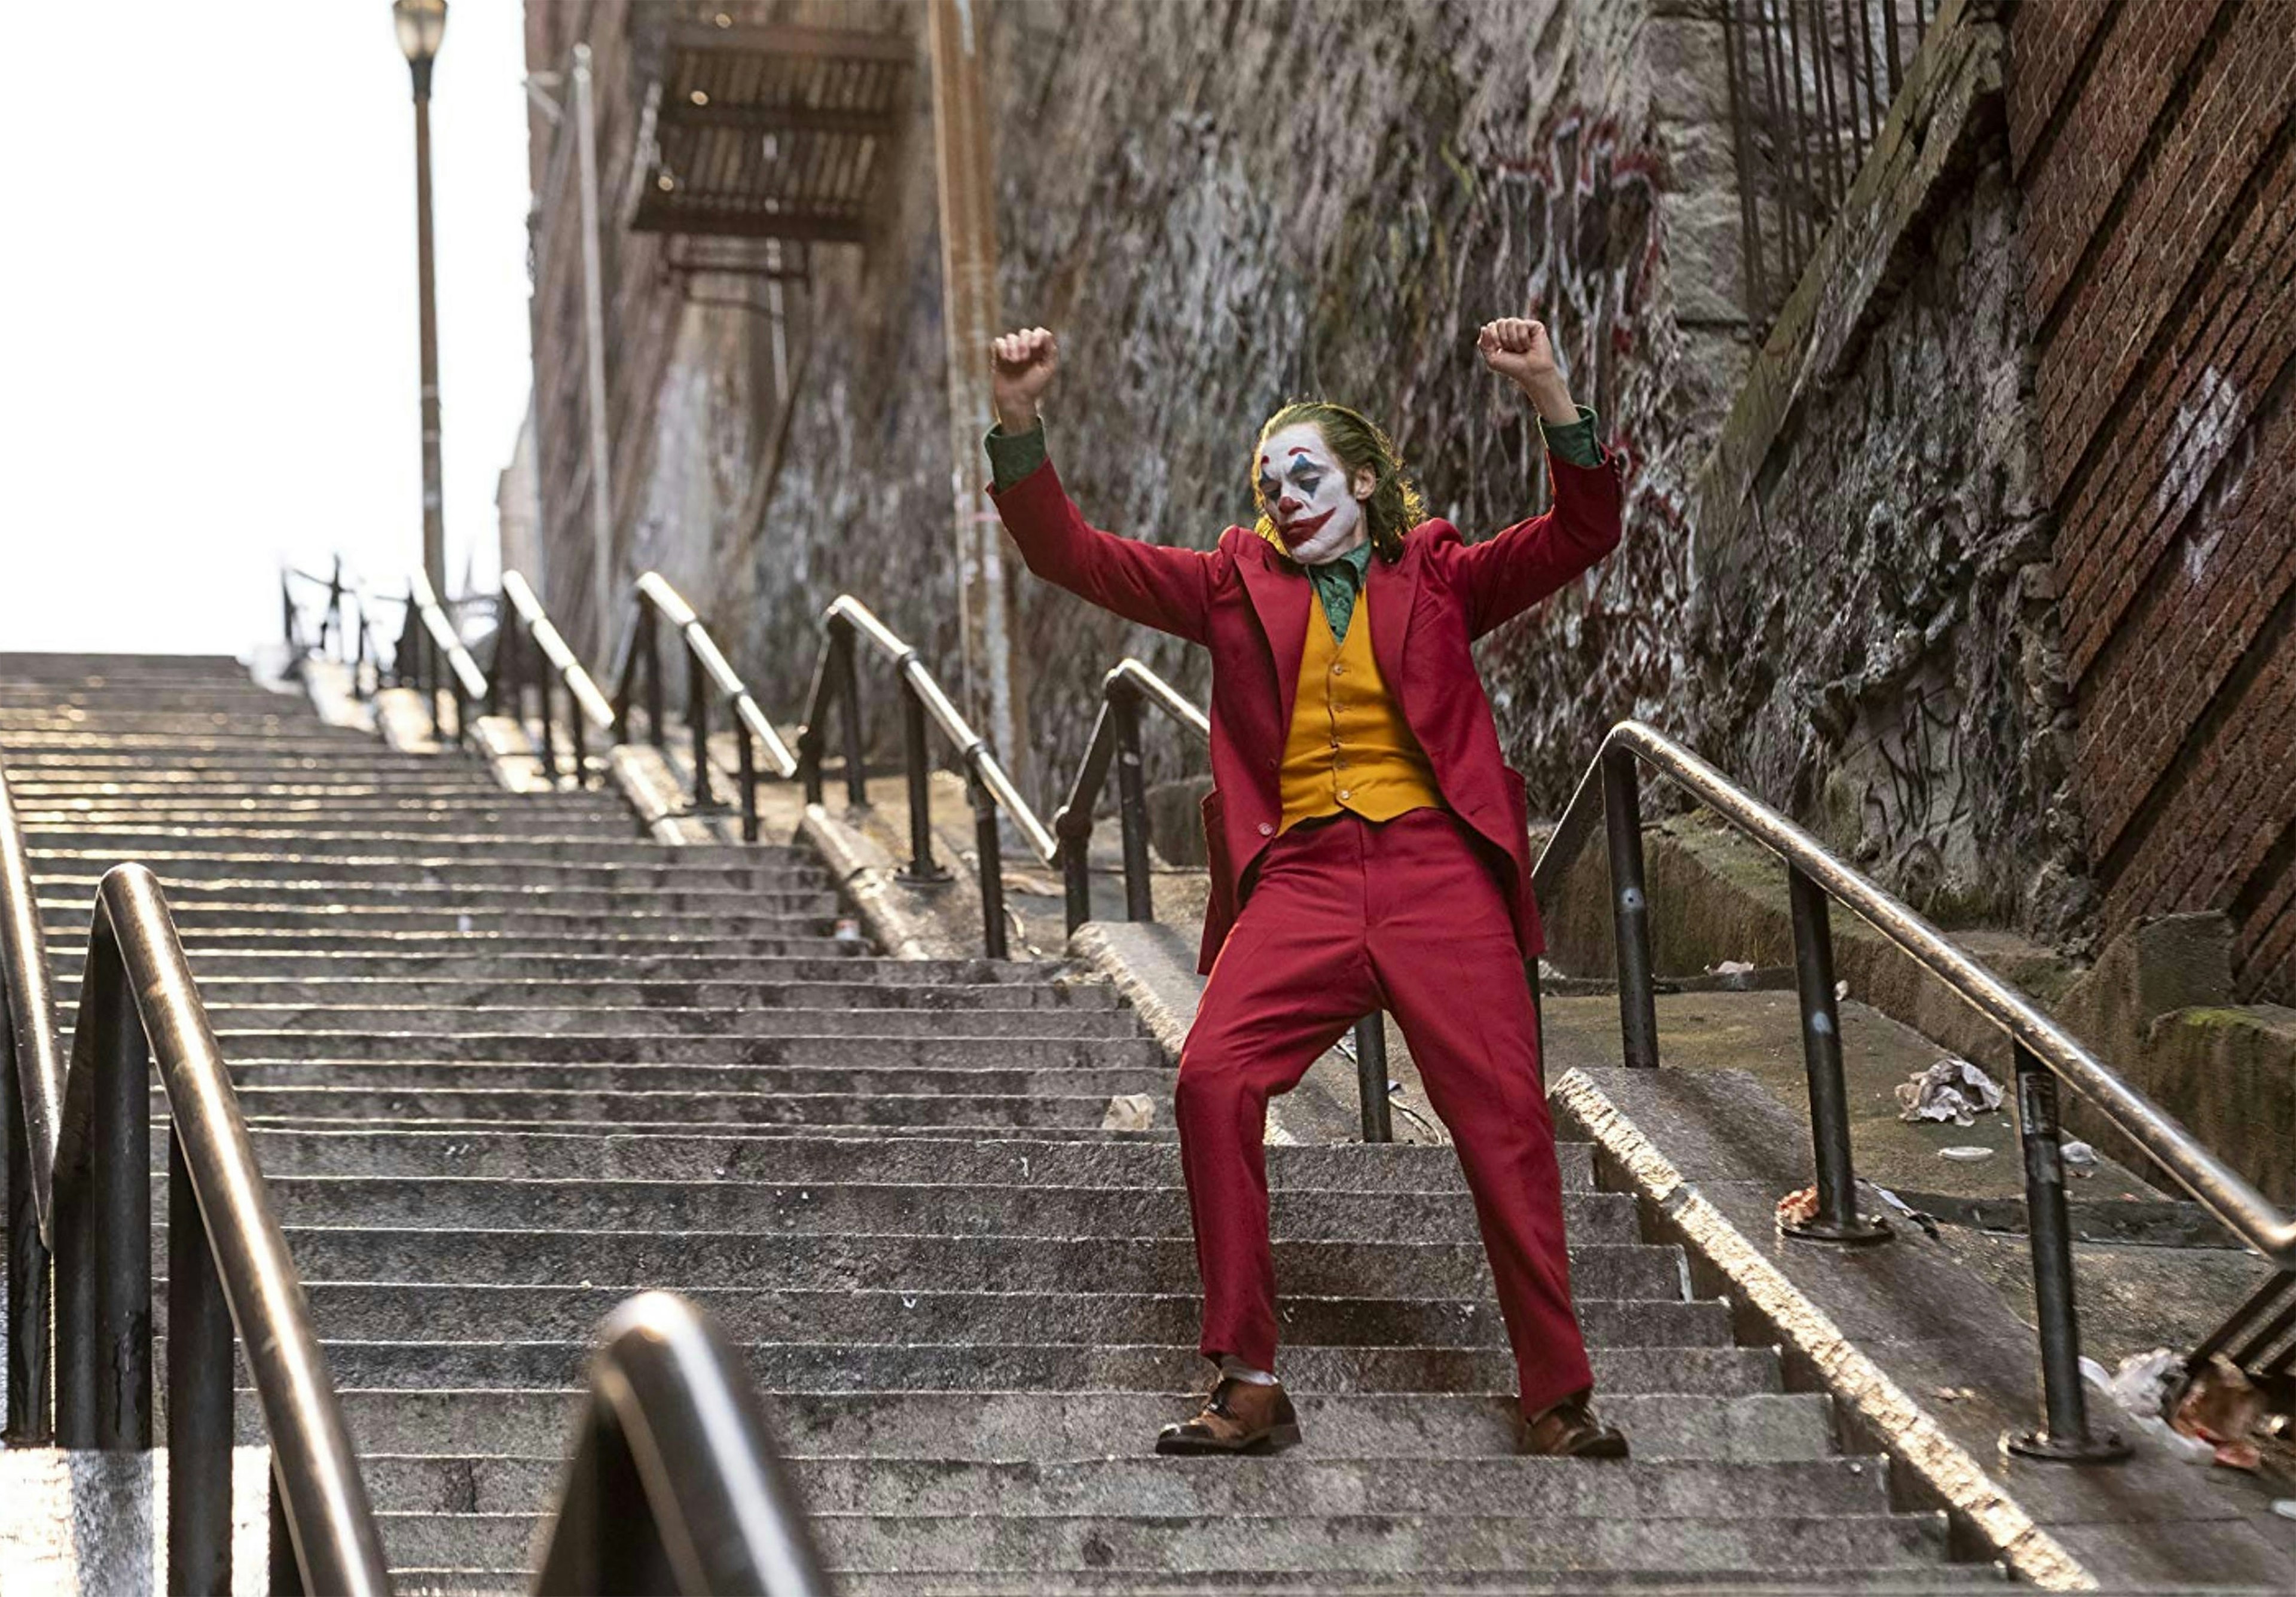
990,454,1623,970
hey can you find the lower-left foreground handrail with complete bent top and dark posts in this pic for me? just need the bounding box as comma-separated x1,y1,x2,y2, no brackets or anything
41,863,390,1592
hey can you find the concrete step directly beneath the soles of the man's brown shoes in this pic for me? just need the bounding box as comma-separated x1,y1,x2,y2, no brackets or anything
363,1448,1889,1519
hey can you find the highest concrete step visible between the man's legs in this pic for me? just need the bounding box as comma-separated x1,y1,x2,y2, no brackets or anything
233,1126,1543,1193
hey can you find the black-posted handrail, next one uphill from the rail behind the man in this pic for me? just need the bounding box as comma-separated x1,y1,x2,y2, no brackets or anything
796,594,1061,959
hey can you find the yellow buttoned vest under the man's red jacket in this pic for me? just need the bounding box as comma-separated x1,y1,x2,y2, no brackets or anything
1277,594,1442,833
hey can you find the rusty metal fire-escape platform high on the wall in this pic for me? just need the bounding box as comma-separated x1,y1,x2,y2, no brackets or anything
629,16,914,243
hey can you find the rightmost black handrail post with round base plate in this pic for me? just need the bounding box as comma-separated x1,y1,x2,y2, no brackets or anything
2004,1042,2129,1464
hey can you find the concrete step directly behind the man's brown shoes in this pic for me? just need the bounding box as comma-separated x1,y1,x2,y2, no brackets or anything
277,1375,1834,1468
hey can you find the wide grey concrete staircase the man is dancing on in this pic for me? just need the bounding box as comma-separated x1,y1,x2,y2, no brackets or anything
0,654,1993,1592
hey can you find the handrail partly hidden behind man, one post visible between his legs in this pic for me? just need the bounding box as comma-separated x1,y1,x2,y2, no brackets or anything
1052,658,1396,1143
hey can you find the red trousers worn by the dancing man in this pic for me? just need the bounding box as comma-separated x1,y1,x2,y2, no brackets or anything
1173,810,1593,1413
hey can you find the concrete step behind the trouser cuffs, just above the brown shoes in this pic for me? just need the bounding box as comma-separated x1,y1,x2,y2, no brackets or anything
237,1338,1779,1400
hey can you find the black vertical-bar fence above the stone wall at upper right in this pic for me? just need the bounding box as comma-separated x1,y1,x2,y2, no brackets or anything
1722,0,1938,332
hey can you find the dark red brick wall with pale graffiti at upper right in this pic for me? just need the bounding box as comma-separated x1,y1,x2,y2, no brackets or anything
2009,0,2296,1003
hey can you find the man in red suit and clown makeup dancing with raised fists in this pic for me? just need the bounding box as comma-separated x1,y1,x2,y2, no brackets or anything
987,317,1626,1457
